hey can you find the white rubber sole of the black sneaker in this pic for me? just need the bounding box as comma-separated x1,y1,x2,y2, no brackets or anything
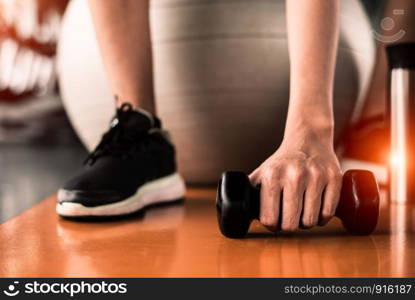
56,173,186,217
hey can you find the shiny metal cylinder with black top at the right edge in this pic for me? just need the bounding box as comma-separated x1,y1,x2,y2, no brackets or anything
386,43,415,203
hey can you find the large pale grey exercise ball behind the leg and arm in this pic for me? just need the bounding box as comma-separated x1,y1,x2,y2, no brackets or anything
58,0,375,183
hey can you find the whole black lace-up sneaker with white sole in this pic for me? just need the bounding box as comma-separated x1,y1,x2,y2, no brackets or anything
56,103,185,218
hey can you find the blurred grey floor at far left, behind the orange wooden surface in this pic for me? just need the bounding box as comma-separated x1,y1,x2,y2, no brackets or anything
0,144,86,223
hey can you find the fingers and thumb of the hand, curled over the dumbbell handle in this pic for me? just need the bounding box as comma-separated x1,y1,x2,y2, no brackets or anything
256,165,342,231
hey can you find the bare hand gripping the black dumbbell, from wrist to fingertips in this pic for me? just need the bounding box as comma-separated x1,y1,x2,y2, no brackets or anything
249,129,342,231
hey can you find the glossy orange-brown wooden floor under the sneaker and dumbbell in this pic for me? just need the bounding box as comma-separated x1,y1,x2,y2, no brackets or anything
0,189,415,277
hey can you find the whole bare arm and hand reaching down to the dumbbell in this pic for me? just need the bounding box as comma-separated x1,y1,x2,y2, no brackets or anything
249,0,342,231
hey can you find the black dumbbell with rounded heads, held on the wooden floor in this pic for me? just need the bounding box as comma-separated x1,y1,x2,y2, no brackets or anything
216,170,379,238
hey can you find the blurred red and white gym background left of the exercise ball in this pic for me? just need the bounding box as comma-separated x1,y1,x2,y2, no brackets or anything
0,0,70,143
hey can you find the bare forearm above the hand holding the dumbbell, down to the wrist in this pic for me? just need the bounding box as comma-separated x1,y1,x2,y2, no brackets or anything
286,0,339,138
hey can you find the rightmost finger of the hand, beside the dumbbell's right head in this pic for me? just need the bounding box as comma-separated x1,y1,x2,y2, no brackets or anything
318,170,342,226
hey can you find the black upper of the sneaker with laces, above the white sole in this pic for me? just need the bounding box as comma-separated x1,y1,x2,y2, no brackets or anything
59,104,176,206
